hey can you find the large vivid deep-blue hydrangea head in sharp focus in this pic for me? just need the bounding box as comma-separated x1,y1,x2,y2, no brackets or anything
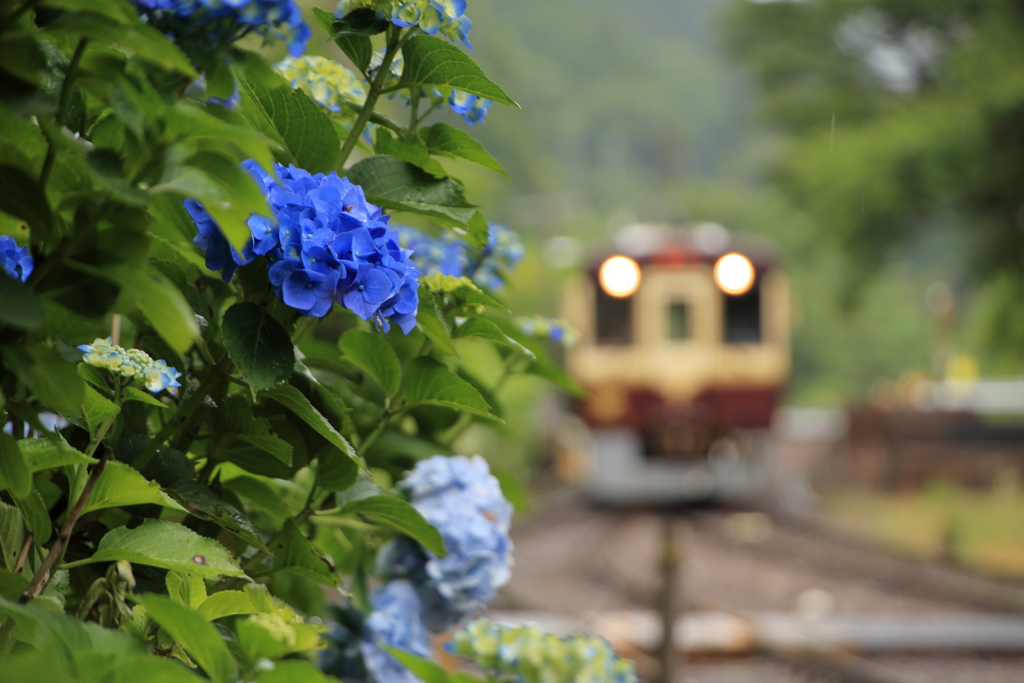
185,160,420,334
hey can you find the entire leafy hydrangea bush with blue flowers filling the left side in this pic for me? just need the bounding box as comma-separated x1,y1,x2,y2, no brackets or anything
0,0,606,683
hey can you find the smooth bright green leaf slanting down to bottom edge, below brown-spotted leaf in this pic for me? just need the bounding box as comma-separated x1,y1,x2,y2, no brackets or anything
139,593,238,683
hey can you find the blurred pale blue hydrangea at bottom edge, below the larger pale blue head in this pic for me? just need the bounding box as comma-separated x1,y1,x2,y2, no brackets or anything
359,580,430,683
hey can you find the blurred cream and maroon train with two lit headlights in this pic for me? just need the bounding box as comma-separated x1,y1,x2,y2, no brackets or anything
562,223,793,505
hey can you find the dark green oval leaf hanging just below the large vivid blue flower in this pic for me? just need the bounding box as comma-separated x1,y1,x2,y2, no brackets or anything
224,301,295,395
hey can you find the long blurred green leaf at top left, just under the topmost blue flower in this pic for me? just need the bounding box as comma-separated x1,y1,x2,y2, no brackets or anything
46,12,199,78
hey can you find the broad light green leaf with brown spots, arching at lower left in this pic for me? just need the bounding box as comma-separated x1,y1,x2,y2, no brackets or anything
65,519,246,579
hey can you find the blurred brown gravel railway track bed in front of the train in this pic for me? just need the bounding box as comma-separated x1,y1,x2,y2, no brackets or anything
502,499,1024,683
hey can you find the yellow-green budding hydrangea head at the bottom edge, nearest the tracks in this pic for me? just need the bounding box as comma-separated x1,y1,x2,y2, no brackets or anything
447,618,638,683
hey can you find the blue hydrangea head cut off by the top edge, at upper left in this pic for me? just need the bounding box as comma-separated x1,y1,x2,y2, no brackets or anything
132,0,311,56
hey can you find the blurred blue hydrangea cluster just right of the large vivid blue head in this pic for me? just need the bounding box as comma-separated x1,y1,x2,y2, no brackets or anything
396,223,525,290
